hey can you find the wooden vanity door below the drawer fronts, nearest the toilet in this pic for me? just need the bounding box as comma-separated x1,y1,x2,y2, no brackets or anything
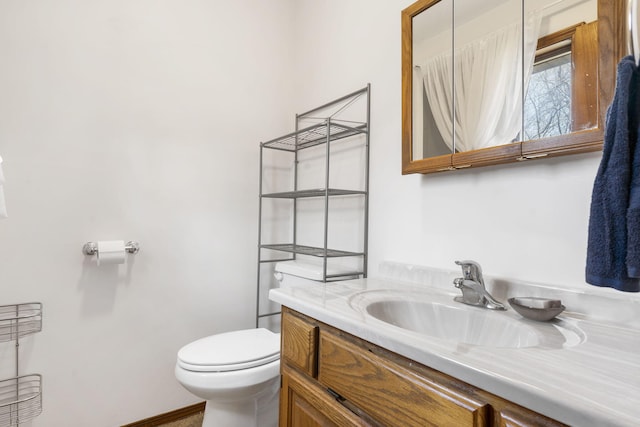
280,366,370,427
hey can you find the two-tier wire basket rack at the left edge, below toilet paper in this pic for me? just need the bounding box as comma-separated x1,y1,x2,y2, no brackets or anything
0,302,42,427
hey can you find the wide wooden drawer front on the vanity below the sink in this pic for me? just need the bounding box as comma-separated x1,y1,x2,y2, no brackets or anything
318,330,490,427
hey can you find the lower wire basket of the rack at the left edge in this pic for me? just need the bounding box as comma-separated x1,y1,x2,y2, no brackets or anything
0,374,42,427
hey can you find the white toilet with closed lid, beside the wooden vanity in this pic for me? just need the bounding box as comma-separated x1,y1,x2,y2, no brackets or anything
175,261,328,427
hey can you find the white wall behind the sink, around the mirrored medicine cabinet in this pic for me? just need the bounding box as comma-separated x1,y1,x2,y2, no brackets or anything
295,0,638,298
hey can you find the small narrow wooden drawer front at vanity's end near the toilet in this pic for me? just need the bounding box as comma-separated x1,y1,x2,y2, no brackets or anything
281,310,318,377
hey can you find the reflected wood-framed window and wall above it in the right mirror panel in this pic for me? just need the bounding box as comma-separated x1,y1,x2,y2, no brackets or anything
523,0,598,141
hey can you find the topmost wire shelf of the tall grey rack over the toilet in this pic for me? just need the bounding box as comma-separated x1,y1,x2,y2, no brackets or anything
262,121,367,151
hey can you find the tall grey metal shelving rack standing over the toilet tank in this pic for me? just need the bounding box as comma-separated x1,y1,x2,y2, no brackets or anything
256,85,371,327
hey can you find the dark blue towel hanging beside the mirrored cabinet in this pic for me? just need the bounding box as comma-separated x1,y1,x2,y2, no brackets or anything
586,56,640,292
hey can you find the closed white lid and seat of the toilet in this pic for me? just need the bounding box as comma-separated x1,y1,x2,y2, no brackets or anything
178,328,280,372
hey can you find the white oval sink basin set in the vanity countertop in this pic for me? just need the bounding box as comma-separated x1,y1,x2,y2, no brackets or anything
350,291,584,348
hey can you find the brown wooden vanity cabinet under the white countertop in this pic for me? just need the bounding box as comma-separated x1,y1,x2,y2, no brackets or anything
280,307,564,427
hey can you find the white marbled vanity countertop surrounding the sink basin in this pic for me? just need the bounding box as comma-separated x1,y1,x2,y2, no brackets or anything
269,278,640,426
